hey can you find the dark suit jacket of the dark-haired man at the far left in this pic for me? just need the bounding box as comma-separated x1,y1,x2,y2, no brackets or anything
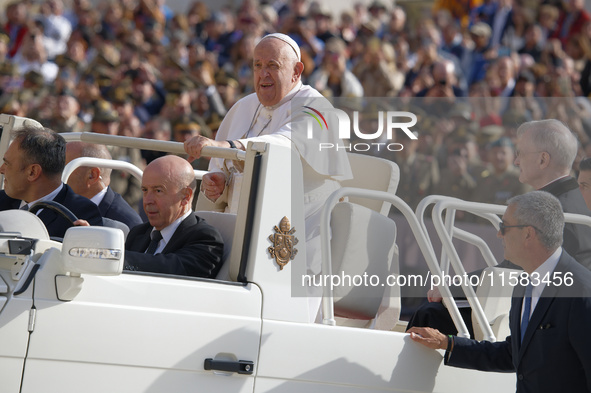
0,184,103,238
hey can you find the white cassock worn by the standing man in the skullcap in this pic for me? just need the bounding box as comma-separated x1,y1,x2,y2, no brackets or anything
200,82,352,319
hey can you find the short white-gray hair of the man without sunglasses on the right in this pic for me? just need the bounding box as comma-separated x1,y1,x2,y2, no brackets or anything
517,119,579,170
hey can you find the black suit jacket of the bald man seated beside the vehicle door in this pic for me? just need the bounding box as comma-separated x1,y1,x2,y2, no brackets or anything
125,213,224,278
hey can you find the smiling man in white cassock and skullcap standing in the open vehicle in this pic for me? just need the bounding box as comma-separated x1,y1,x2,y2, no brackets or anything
185,33,352,320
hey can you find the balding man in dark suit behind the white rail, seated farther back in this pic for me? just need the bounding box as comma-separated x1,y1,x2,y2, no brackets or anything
66,142,142,228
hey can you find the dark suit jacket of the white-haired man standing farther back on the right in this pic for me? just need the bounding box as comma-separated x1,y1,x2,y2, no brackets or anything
540,176,591,270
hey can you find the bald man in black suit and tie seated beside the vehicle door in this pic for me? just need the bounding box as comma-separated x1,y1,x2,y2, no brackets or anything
125,155,224,278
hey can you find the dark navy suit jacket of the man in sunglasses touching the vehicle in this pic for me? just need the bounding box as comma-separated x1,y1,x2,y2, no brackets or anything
446,250,591,393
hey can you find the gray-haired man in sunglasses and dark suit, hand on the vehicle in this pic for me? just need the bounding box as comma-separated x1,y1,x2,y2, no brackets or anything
409,191,591,393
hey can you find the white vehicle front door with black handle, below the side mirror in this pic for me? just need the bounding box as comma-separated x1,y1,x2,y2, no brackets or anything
22,269,262,393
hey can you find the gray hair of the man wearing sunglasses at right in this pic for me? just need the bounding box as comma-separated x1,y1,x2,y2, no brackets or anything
507,191,564,251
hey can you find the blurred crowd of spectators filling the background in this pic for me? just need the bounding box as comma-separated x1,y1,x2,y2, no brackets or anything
0,0,591,211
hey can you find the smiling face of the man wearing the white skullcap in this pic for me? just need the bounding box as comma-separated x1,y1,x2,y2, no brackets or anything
253,38,303,106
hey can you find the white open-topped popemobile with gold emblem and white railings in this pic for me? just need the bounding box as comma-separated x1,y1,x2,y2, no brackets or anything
0,115,588,393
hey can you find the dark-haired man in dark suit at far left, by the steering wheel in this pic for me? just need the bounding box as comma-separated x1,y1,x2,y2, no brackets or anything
0,126,102,238
